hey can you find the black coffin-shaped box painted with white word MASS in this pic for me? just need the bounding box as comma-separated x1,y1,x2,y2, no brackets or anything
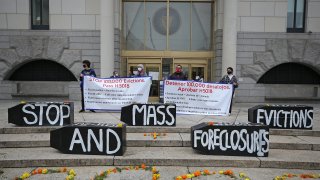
121,104,176,126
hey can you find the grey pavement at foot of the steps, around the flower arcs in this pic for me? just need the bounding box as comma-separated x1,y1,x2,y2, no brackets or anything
0,166,320,180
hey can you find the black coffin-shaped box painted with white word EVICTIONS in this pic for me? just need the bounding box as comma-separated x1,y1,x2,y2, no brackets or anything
248,105,313,130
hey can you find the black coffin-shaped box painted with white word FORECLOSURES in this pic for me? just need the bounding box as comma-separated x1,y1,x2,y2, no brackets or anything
191,122,269,157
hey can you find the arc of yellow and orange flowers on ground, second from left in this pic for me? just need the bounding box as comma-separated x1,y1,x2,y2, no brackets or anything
91,164,160,180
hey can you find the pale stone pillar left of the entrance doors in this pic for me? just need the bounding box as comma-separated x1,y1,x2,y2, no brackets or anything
100,0,114,78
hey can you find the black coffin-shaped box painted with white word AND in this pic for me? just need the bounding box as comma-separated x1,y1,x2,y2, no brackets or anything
50,123,126,156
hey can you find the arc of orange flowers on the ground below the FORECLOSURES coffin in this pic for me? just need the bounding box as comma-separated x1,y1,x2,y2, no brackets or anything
175,169,250,180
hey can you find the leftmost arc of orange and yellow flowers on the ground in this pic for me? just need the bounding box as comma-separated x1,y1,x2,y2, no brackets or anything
15,167,77,180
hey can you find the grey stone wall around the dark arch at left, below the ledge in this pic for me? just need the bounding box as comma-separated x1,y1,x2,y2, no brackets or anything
0,30,100,99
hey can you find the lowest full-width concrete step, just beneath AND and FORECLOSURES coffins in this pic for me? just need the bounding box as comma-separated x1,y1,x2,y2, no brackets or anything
0,147,320,170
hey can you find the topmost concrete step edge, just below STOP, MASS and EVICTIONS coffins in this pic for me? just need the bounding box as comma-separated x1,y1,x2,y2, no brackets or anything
0,126,320,137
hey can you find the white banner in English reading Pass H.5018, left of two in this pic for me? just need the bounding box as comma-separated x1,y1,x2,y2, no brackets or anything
83,76,151,110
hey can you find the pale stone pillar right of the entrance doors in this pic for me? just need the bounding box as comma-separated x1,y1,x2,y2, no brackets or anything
222,0,238,76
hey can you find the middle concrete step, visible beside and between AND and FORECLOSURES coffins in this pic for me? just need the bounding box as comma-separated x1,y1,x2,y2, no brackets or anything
0,133,320,151
